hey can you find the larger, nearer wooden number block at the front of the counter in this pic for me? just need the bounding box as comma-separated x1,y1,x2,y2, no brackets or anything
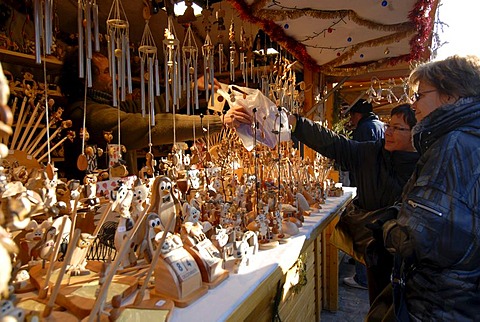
152,236,208,307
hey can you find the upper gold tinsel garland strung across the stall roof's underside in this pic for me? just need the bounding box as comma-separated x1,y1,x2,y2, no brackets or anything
256,9,414,32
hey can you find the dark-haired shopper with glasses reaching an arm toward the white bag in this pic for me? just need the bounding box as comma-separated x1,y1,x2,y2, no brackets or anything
289,104,418,303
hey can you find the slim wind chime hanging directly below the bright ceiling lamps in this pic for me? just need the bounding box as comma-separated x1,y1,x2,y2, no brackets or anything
182,25,200,115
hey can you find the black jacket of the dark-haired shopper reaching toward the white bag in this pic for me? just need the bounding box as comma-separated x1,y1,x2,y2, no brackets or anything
292,117,418,211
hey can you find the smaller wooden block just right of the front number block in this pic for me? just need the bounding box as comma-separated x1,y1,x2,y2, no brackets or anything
187,239,229,289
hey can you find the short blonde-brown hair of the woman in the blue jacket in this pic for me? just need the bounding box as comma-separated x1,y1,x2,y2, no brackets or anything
409,55,480,98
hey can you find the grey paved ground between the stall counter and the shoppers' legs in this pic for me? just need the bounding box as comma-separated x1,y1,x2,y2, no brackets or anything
320,252,369,322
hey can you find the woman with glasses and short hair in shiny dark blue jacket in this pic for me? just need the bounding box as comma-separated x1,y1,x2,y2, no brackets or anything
383,56,480,321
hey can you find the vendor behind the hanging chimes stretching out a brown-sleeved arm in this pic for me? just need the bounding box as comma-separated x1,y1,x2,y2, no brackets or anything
59,49,251,179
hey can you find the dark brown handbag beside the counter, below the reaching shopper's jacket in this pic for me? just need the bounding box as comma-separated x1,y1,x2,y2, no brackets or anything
330,199,388,264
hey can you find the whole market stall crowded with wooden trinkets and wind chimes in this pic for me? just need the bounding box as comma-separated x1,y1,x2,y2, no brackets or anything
0,0,437,321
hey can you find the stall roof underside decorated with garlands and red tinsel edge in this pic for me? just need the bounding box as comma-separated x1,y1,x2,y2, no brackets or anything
227,0,438,76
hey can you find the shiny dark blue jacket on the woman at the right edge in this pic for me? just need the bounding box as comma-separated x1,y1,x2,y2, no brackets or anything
384,97,480,321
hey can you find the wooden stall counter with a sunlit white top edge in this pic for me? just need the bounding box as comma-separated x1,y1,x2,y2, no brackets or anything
172,188,355,321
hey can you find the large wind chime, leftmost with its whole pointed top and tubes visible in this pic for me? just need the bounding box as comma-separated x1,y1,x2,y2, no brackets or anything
107,0,132,107
